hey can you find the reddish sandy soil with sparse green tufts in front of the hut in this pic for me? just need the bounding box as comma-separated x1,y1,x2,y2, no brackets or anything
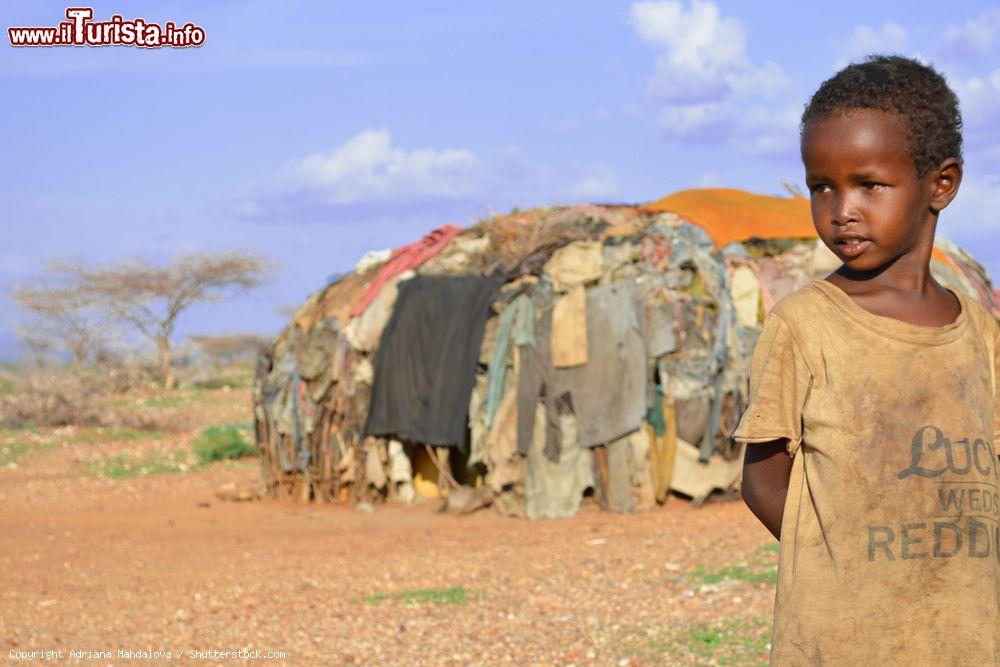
0,392,776,665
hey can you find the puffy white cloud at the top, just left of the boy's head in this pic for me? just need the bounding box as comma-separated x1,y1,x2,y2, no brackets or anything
630,0,798,153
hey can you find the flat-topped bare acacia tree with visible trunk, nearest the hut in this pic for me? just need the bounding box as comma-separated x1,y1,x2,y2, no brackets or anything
62,251,272,389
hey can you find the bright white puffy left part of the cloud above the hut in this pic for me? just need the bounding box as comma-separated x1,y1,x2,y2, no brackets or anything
283,129,483,204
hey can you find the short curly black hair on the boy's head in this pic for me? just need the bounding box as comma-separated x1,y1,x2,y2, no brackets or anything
800,56,962,177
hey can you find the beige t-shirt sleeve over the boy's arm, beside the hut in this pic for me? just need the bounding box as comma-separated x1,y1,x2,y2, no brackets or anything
733,313,811,456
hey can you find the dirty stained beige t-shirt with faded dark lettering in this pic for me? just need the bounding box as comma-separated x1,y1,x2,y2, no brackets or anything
734,281,1000,665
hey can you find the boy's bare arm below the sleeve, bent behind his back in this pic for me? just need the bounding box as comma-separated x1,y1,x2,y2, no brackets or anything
742,439,792,540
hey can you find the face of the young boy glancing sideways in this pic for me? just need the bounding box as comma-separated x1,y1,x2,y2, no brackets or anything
802,109,935,271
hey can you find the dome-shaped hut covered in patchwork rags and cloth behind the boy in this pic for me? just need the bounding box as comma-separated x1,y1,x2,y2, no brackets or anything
254,189,1000,519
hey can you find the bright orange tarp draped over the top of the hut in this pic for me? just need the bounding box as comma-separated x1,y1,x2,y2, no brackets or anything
639,188,956,269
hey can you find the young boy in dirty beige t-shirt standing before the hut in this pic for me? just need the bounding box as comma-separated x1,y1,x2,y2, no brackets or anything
734,56,1000,665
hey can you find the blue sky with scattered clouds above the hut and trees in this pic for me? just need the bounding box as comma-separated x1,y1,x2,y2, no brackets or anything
0,0,1000,356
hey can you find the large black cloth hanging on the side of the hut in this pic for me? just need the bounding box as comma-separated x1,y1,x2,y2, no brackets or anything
365,276,501,451
